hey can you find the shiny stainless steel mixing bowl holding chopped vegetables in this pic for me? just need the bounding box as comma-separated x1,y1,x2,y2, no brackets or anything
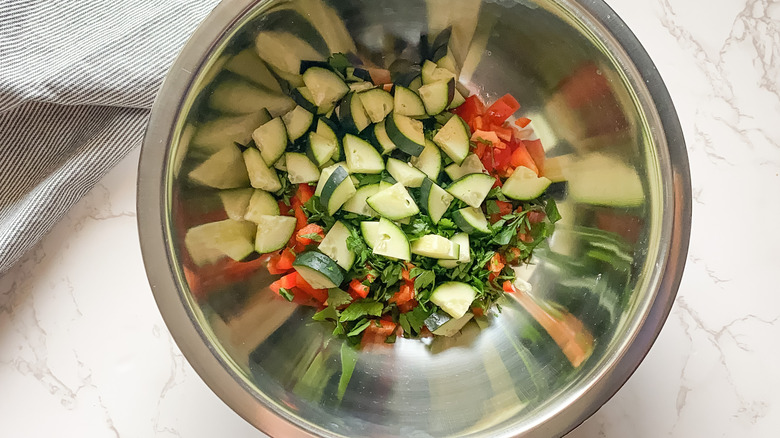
138,0,691,437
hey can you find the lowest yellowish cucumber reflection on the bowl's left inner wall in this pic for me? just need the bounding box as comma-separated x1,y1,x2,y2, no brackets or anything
184,219,257,266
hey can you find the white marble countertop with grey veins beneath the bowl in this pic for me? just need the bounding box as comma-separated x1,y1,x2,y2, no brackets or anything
0,0,780,438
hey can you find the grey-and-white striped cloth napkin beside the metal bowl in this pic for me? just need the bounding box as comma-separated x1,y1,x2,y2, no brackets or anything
0,0,217,278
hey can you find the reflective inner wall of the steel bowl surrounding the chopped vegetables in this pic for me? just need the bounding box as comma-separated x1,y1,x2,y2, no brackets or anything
163,0,672,437
